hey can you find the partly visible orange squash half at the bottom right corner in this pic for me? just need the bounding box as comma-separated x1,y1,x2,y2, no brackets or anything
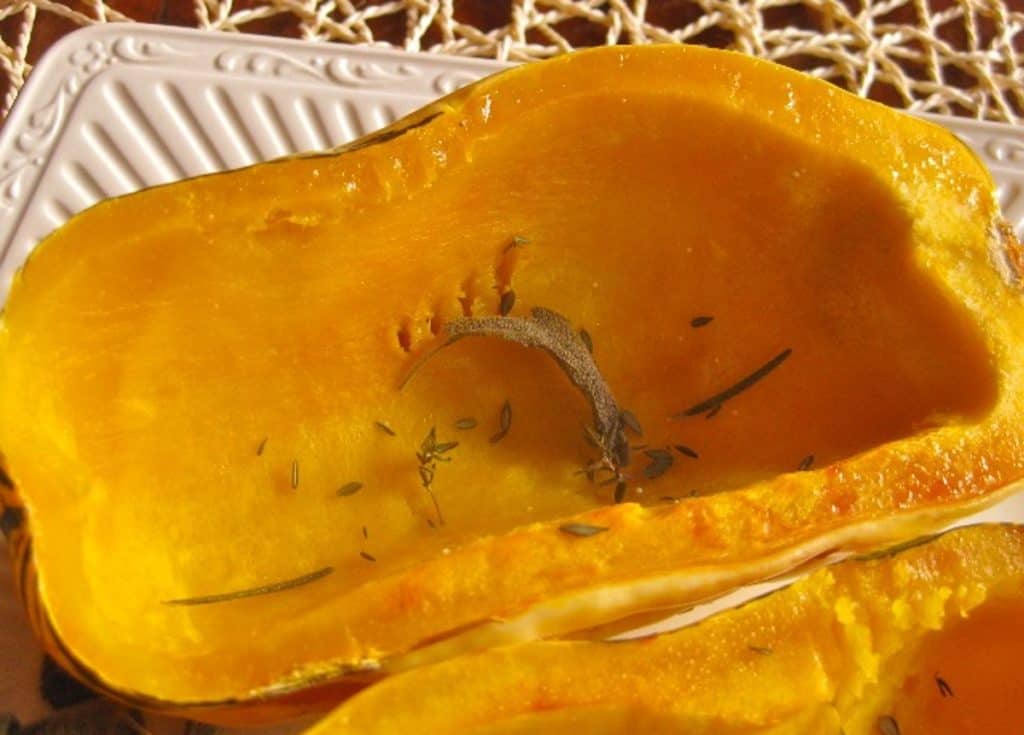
308,526,1024,735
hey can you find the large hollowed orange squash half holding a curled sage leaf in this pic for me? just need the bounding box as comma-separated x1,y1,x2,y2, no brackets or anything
0,47,1024,720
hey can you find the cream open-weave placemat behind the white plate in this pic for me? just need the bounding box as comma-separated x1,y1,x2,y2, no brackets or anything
0,0,1024,123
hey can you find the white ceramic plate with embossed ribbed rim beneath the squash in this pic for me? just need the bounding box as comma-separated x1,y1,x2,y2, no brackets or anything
0,25,1024,733
